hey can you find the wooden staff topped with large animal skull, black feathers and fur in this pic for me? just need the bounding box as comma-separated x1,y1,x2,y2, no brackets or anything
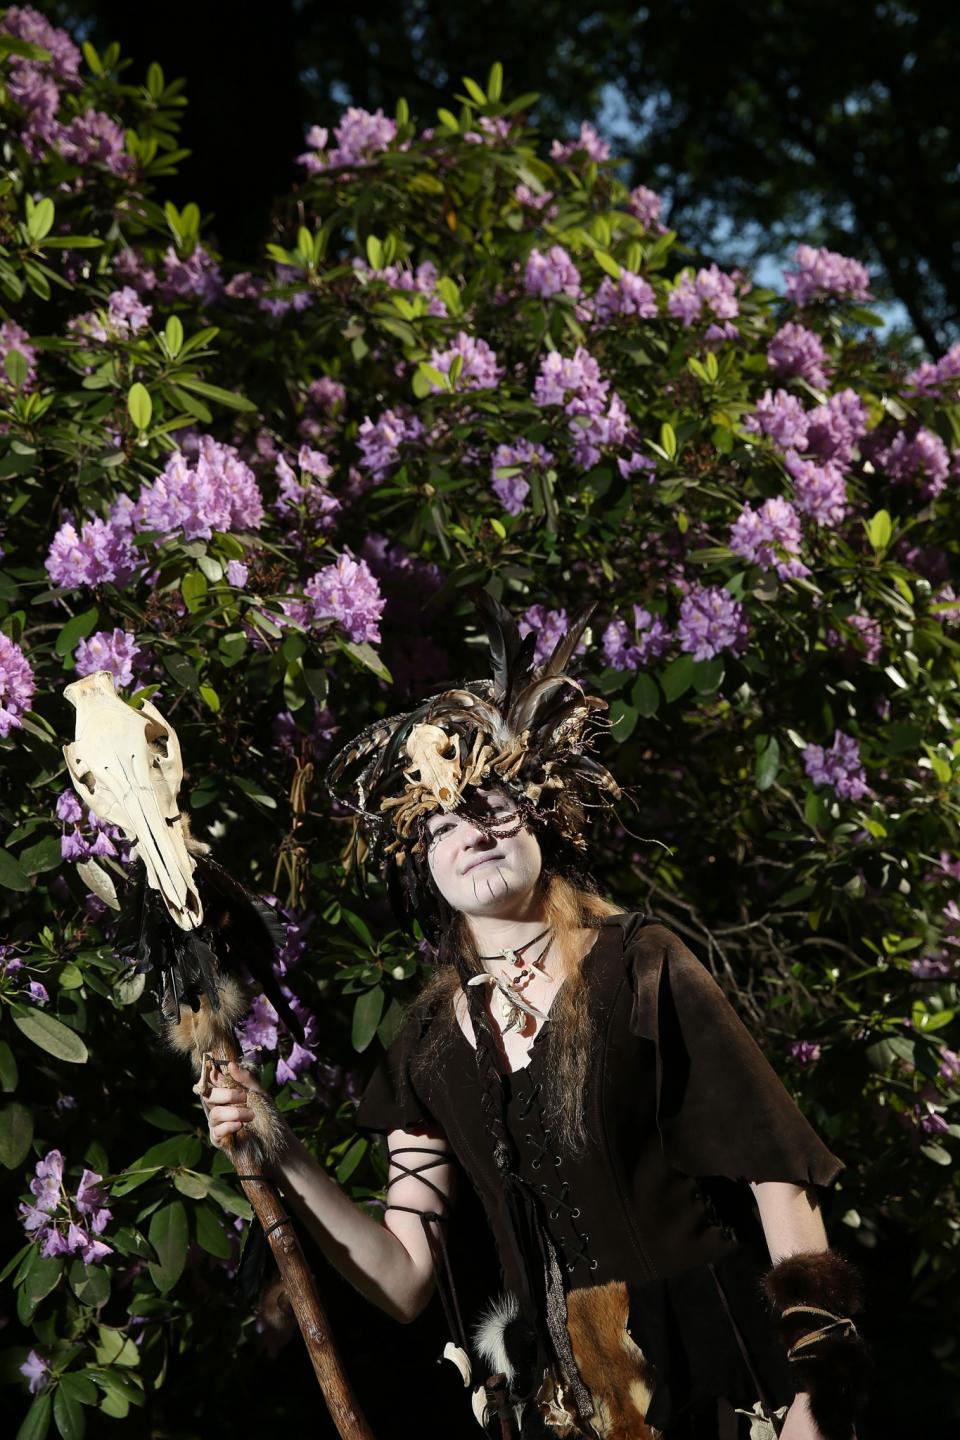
63,670,373,1440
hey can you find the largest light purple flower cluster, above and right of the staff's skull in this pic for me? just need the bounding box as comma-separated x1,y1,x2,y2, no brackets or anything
135,435,263,540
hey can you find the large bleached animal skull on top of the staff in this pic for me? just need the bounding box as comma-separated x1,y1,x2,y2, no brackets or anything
63,670,203,930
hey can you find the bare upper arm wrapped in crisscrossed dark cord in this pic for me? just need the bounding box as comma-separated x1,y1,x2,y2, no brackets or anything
383,1128,453,1274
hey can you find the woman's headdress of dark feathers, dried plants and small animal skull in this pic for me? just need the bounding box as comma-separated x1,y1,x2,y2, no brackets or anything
327,590,620,898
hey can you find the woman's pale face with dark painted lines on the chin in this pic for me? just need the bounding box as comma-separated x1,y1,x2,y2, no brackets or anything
427,789,543,916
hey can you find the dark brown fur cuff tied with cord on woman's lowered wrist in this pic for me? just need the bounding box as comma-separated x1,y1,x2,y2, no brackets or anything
763,1250,866,1440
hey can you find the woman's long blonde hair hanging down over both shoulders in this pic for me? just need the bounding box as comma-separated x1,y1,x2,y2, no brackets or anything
412,874,623,1153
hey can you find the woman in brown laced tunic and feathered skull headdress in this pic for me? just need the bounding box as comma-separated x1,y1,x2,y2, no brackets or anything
201,600,862,1440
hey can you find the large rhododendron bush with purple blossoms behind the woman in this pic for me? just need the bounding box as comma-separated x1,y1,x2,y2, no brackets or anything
0,7,960,1440
